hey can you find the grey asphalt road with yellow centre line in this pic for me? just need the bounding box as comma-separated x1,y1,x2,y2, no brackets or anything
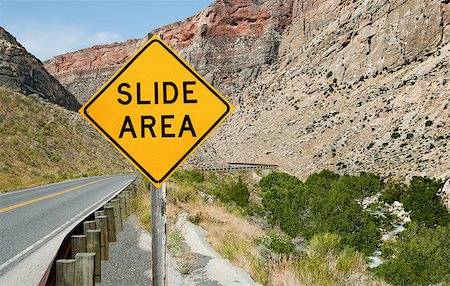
0,175,136,280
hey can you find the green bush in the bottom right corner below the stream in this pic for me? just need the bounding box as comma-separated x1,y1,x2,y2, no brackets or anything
375,224,450,285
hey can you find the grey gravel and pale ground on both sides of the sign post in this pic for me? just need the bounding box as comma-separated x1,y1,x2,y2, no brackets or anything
96,215,259,286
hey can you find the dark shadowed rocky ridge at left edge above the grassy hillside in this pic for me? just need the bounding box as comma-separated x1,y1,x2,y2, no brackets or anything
0,27,81,111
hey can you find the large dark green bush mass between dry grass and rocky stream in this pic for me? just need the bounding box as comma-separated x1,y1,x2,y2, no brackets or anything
260,171,383,254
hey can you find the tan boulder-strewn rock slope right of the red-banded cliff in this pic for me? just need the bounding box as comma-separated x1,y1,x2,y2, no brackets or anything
225,0,450,178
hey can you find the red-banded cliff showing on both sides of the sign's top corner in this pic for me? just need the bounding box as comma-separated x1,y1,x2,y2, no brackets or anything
45,0,293,103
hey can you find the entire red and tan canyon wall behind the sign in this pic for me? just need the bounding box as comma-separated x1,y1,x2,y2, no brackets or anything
46,0,450,178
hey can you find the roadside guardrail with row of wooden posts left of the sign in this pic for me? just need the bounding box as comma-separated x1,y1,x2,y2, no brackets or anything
39,176,141,286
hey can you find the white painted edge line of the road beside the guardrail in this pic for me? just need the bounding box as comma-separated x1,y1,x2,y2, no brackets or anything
0,179,134,276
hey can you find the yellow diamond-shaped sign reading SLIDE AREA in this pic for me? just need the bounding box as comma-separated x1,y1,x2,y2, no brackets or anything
80,35,234,187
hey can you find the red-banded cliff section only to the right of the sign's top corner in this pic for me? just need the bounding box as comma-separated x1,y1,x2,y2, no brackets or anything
150,0,293,97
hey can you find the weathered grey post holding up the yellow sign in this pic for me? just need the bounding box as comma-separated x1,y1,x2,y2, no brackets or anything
150,183,168,286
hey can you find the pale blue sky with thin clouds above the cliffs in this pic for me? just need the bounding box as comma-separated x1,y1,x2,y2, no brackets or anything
0,0,214,61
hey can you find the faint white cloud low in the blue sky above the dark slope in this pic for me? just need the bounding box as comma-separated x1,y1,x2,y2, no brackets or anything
5,22,123,61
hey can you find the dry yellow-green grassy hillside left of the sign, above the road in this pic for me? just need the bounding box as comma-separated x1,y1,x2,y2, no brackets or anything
0,87,133,192
